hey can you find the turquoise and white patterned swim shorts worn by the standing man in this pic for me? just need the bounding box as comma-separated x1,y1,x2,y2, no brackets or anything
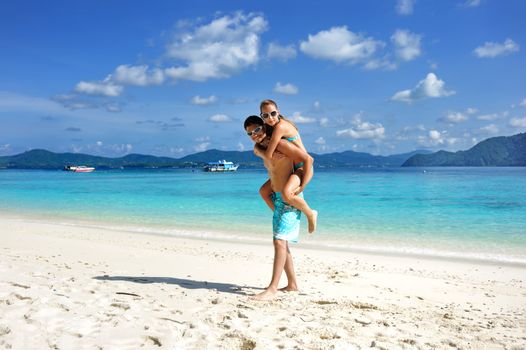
272,192,303,243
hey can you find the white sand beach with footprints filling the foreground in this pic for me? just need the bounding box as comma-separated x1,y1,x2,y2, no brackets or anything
0,218,526,349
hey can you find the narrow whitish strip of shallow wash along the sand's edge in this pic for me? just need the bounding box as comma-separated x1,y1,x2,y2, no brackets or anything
4,212,526,267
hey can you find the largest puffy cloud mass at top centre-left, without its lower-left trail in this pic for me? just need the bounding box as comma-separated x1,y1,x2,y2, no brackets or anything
165,12,267,81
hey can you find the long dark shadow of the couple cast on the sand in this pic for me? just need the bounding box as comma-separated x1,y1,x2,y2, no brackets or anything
93,275,263,295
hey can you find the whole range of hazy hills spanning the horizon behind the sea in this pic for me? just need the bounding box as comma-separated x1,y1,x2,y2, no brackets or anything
0,133,526,170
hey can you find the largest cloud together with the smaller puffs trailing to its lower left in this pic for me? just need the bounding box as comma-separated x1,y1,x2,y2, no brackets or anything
70,12,267,97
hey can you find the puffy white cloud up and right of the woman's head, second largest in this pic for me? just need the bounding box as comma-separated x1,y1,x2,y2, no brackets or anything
300,26,385,64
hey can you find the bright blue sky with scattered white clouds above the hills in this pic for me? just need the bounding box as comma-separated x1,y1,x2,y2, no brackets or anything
0,0,526,158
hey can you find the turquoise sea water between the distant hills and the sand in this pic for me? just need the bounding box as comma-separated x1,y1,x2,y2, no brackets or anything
0,168,526,264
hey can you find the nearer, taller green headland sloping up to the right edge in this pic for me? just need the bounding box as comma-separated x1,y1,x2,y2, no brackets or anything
402,133,526,167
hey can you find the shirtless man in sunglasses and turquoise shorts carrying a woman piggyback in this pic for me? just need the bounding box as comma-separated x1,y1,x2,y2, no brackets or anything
244,116,314,300
